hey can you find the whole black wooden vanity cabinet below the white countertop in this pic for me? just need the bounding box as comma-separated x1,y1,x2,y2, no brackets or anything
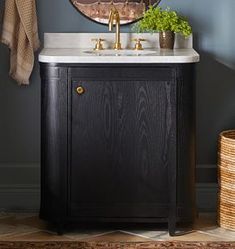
40,63,195,234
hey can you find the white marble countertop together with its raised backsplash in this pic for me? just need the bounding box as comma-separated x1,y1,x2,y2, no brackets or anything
39,33,200,63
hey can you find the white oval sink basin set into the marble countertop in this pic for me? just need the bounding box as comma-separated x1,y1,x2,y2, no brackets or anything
83,49,157,56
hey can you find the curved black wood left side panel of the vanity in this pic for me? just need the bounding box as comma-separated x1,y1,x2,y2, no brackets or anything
40,66,67,222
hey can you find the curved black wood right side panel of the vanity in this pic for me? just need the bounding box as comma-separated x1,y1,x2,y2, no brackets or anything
176,64,196,220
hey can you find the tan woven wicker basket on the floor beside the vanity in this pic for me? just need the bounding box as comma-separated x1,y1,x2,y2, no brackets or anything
218,130,235,231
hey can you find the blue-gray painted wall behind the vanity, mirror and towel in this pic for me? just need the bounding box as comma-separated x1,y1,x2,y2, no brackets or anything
0,0,235,208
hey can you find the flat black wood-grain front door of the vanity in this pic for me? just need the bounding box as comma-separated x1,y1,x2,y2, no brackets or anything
69,68,176,217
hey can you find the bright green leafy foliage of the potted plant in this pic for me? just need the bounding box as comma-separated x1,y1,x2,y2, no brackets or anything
134,6,192,37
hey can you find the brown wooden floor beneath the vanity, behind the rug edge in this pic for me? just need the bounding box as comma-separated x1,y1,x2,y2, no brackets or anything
0,213,235,242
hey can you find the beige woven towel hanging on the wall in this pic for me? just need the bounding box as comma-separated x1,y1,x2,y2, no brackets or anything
1,0,39,84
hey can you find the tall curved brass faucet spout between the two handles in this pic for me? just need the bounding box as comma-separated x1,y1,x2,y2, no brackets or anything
108,7,122,50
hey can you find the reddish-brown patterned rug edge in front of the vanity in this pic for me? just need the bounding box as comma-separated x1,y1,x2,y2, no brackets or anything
0,241,235,249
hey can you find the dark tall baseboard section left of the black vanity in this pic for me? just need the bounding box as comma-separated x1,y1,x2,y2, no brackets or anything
0,163,40,212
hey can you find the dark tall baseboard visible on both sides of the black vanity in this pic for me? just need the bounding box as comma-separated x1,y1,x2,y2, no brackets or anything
0,163,218,212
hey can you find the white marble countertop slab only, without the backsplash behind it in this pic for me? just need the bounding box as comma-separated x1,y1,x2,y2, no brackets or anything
39,48,199,63
